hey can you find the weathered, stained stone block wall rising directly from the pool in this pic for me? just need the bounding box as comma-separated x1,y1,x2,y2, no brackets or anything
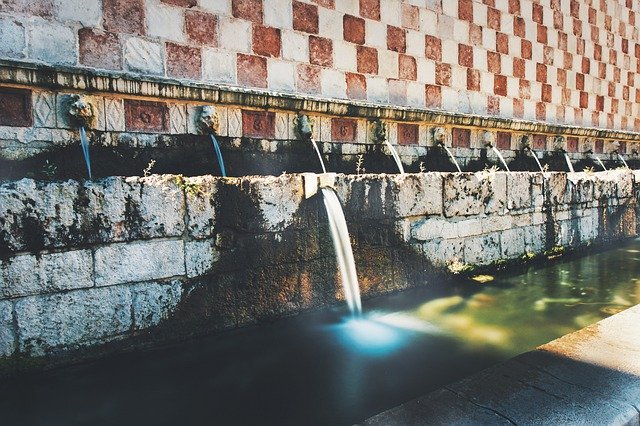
0,171,640,359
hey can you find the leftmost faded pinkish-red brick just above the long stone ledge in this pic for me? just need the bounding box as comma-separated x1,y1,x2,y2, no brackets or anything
78,28,122,70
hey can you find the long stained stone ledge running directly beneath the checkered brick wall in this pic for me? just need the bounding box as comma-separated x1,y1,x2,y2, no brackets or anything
0,60,640,140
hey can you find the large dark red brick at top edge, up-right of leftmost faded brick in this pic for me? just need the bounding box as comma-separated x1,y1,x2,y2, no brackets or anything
102,0,145,35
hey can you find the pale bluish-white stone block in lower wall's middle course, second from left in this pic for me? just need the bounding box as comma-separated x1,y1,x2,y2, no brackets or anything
95,240,185,287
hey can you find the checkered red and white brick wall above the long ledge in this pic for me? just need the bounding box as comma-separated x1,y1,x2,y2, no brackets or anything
0,0,640,131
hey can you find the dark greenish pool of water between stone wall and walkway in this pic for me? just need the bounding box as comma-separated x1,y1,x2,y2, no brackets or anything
0,240,640,425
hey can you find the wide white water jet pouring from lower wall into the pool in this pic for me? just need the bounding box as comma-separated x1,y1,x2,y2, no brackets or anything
321,188,362,316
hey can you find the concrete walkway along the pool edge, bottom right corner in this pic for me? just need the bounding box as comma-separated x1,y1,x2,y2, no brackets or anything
364,305,640,425
